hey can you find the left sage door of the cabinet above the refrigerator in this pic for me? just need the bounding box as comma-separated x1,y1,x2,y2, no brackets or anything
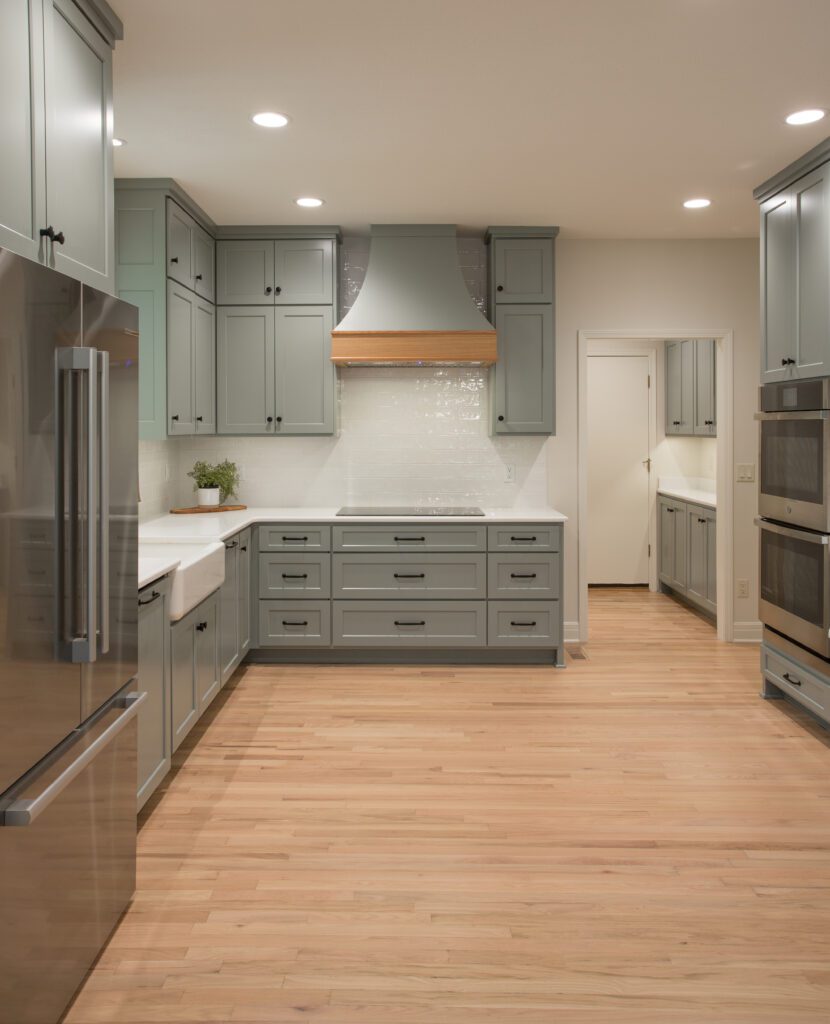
0,0,46,259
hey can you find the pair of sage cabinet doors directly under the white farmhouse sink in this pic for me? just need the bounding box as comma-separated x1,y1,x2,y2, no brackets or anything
170,592,220,751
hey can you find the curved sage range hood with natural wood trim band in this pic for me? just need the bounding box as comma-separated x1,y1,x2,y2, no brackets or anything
332,224,496,367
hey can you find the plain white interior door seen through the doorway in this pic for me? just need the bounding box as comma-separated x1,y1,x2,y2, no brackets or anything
587,355,651,585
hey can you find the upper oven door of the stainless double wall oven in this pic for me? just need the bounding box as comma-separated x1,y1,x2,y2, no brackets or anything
758,410,830,532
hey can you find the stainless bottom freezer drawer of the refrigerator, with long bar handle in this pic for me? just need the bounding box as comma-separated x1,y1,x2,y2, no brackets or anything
0,691,144,1024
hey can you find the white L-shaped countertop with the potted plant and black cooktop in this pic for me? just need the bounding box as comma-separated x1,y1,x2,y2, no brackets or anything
138,507,567,544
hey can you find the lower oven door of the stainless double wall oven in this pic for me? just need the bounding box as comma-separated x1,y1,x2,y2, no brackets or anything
755,519,830,657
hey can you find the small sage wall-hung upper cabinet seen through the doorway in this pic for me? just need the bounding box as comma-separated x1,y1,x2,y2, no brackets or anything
665,338,717,437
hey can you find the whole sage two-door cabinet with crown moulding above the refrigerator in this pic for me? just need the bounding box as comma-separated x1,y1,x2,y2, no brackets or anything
0,0,121,292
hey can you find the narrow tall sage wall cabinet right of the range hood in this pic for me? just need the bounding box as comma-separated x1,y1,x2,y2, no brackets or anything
486,227,559,434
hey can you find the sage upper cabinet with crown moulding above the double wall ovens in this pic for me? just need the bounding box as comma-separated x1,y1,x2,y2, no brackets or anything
755,141,830,382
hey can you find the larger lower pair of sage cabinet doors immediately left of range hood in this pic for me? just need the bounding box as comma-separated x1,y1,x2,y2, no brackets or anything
217,306,335,435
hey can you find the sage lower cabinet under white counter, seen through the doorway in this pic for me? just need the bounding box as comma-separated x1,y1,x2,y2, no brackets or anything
658,495,717,615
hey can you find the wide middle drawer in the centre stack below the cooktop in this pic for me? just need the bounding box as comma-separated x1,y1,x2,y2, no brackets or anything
333,554,487,600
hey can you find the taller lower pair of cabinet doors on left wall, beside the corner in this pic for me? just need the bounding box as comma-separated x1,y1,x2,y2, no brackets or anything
167,281,216,436
